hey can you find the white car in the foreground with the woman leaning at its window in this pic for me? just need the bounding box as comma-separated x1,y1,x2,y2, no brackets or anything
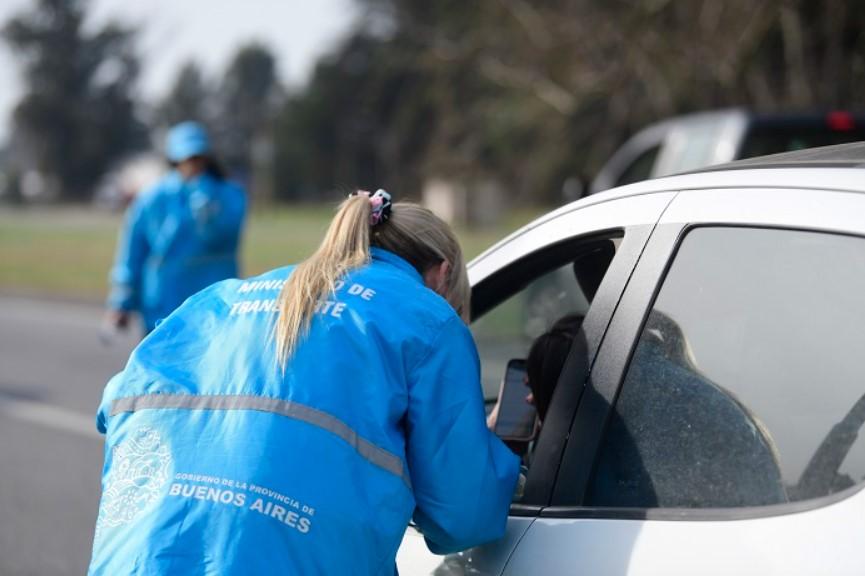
398,143,865,576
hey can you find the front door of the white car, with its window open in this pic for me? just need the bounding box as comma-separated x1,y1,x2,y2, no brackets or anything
397,192,675,575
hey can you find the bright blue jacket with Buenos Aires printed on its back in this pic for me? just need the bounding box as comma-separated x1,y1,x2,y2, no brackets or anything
90,249,519,576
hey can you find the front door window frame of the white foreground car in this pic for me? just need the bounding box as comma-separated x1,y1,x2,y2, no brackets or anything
470,192,675,516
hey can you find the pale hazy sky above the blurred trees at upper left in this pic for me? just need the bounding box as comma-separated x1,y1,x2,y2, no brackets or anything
0,0,356,138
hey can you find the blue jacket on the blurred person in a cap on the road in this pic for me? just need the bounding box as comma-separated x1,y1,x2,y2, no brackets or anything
108,171,246,332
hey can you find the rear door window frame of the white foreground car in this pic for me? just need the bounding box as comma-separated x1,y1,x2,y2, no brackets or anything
540,189,865,521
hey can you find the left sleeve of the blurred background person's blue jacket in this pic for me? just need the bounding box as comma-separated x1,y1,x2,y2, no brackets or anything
108,198,150,310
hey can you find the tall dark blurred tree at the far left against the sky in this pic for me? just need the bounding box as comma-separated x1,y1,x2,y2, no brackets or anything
3,0,145,200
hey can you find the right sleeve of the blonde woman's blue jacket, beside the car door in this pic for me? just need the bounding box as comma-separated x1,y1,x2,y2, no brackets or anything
406,316,519,554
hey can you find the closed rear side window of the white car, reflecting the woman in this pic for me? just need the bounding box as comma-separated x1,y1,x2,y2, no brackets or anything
586,228,865,508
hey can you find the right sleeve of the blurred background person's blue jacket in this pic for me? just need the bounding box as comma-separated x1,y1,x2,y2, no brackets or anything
189,176,246,250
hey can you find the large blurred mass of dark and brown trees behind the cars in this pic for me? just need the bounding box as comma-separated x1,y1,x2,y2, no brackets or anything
277,0,865,203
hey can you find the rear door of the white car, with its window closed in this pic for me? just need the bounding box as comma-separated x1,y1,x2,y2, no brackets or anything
505,188,865,576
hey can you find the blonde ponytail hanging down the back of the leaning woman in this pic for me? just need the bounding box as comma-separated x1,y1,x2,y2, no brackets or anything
275,195,370,369
